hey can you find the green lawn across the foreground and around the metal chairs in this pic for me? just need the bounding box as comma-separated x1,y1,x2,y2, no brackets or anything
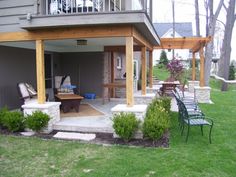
0,85,236,177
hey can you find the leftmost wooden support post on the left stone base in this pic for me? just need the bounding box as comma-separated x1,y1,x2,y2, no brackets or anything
36,40,46,104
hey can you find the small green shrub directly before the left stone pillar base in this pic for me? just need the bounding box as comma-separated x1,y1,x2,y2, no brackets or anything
26,111,50,132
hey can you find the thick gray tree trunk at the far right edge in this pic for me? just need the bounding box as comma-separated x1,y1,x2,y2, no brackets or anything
219,0,236,91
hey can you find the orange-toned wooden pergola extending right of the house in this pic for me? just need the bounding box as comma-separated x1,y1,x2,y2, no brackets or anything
154,37,211,87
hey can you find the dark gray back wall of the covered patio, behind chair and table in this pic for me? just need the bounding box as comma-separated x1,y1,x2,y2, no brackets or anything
61,52,103,97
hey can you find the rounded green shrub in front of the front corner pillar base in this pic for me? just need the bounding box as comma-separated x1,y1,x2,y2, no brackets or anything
113,113,139,142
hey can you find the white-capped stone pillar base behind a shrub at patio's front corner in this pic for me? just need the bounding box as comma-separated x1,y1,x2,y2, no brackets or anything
111,104,147,139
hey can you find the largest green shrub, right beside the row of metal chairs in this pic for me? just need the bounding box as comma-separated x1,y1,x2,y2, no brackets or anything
143,98,170,141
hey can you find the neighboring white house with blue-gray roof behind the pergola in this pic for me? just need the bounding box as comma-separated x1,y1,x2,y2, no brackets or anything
153,22,193,67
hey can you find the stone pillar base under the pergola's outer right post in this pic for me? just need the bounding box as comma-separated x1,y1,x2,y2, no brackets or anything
194,86,211,103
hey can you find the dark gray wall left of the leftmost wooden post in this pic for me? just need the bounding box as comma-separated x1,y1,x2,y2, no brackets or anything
0,46,36,109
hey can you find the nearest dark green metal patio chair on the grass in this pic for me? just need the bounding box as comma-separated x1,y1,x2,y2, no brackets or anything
179,101,213,143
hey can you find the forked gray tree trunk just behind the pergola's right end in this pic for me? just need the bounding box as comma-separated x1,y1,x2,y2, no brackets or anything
204,0,224,85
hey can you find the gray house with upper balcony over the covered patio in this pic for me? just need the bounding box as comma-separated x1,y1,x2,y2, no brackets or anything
0,0,160,109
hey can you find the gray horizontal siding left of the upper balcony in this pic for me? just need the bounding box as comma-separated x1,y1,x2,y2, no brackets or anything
0,0,38,32
